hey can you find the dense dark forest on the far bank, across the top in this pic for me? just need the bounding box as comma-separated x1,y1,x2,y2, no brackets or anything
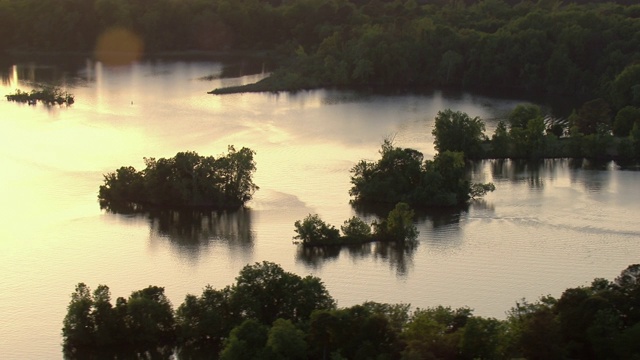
0,0,640,105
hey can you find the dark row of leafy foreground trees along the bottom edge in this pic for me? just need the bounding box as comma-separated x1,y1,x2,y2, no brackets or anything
62,262,640,360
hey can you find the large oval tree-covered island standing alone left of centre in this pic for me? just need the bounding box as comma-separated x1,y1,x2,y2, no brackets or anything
98,146,259,211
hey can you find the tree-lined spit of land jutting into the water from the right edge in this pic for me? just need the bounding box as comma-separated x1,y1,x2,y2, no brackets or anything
432,105,640,160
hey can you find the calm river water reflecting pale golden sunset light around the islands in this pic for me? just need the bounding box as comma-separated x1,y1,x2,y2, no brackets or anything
0,59,640,359
